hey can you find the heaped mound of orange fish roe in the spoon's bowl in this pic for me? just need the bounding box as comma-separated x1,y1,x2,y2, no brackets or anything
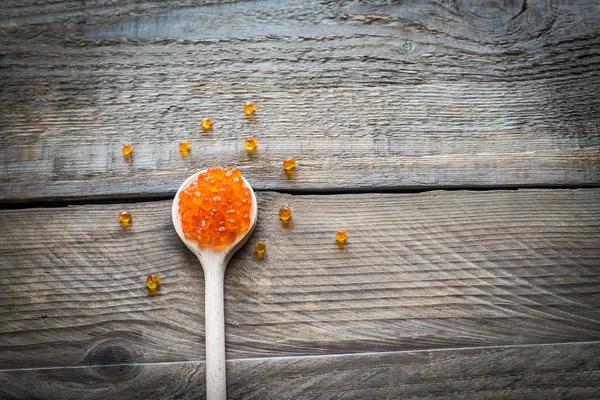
179,168,252,249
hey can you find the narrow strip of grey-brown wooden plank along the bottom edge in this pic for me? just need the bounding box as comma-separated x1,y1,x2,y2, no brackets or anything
0,342,600,400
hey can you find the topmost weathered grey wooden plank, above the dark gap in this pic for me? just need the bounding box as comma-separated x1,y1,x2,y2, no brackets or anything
0,0,600,201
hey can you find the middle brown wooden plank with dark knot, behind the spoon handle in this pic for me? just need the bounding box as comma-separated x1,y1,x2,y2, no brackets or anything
0,189,600,368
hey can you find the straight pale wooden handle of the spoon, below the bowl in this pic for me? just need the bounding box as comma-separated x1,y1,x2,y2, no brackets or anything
204,265,227,400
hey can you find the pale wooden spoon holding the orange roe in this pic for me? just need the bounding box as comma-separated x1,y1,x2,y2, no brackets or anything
171,170,258,400
